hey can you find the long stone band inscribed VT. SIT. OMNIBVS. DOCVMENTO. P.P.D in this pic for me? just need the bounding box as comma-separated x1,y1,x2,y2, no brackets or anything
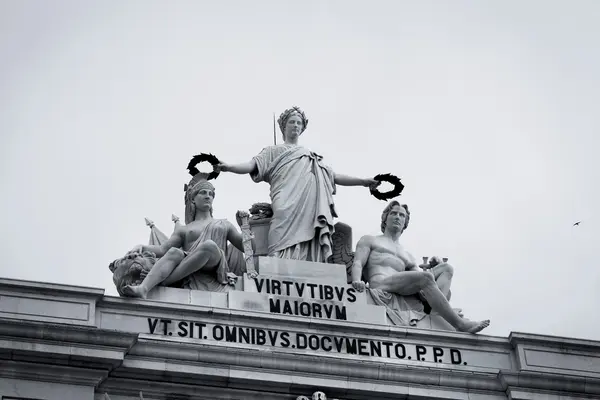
100,312,512,372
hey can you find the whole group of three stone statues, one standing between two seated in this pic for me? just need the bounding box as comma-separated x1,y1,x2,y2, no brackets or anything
109,107,489,333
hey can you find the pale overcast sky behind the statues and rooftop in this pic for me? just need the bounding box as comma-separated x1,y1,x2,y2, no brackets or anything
0,0,600,339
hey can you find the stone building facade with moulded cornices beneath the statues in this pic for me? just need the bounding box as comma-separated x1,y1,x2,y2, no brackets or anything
0,268,600,400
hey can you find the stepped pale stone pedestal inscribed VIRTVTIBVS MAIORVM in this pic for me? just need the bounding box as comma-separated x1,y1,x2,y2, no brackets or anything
148,257,387,325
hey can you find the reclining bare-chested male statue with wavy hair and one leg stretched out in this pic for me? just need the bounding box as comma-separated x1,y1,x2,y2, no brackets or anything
352,201,490,333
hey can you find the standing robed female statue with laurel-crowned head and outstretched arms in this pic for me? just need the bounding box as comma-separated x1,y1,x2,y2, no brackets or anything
215,107,379,262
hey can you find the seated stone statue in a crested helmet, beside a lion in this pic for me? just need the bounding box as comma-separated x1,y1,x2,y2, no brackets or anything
111,173,247,298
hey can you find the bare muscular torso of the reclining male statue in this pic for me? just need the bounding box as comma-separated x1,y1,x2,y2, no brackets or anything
364,236,417,287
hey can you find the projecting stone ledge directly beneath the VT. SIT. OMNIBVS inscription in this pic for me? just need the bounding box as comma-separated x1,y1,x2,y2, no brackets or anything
130,335,503,391
